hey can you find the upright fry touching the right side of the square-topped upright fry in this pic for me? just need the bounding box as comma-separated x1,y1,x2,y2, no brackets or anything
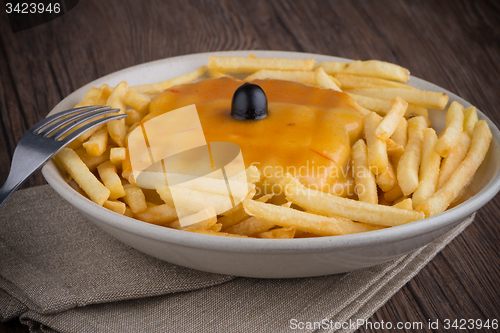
412,128,441,207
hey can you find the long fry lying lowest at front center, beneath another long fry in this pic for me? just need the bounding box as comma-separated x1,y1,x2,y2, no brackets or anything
243,200,377,236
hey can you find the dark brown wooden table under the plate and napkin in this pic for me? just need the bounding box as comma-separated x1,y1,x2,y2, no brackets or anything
0,0,500,332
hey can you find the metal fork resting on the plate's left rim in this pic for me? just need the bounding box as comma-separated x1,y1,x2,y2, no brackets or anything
0,106,127,207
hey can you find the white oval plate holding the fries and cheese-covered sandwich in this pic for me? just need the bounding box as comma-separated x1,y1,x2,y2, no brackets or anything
42,50,500,278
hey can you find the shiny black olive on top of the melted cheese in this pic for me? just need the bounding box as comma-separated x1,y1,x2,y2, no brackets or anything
231,83,267,120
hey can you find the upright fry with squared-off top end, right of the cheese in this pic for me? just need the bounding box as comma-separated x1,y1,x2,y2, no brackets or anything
397,117,427,196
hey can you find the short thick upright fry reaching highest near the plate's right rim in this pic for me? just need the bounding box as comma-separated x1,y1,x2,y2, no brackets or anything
435,101,464,157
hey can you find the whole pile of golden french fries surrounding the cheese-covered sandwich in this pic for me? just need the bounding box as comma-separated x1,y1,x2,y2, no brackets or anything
55,55,492,239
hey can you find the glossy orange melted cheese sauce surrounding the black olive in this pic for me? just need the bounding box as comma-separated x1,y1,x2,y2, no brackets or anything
147,78,363,193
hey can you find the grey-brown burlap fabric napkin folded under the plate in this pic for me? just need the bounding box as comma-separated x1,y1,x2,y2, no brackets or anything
0,185,473,332
